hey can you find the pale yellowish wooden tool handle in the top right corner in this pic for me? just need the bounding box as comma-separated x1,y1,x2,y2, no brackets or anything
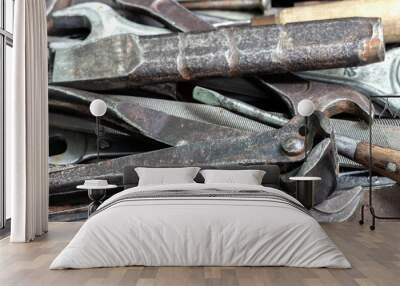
275,0,400,43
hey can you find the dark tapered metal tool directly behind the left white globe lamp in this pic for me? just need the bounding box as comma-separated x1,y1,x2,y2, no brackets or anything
49,87,253,146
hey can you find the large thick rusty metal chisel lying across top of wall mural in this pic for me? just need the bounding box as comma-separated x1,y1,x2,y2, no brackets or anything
52,18,384,90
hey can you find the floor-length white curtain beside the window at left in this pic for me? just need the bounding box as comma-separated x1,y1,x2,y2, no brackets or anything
5,0,49,242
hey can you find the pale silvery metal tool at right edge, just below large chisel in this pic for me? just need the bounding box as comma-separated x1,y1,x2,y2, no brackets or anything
298,48,400,115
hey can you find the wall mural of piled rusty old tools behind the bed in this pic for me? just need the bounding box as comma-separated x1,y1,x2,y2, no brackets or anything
46,0,400,221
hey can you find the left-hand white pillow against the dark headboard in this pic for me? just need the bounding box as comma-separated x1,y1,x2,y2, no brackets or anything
135,167,200,186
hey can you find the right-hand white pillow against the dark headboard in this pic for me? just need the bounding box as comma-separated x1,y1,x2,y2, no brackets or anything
200,169,265,185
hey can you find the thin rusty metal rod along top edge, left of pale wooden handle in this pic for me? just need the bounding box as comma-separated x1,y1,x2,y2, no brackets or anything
178,0,272,12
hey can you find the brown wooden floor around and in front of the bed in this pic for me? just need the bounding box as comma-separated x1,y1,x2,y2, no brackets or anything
0,222,400,286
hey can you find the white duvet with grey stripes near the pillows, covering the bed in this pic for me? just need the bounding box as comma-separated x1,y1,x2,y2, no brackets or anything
50,184,350,269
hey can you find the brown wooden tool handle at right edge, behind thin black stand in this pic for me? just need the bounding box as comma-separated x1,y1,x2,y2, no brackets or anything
354,142,400,182
